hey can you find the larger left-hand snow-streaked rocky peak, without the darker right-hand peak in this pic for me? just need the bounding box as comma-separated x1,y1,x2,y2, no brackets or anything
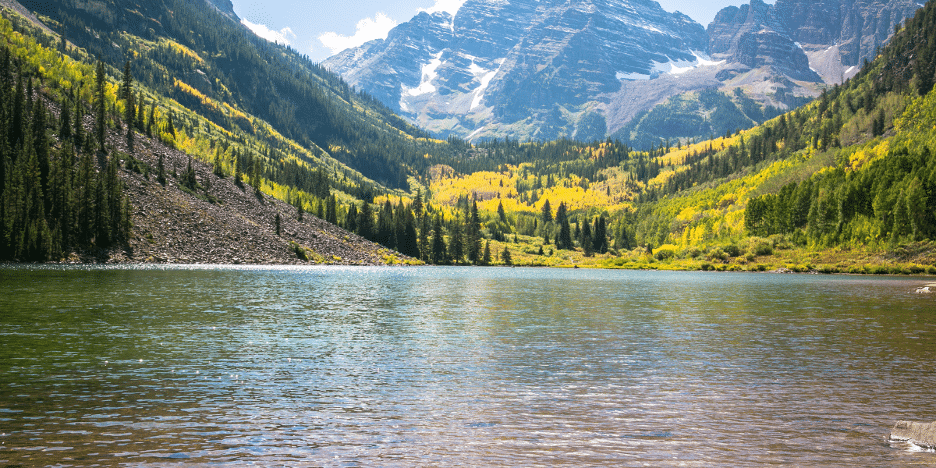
323,0,708,140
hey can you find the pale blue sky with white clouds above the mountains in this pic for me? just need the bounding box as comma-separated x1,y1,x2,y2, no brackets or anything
232,0,773,62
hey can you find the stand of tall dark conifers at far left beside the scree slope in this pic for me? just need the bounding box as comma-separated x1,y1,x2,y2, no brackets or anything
0,46,131,261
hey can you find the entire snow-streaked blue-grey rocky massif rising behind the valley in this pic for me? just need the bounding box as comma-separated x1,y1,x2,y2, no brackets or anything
323,0,920,145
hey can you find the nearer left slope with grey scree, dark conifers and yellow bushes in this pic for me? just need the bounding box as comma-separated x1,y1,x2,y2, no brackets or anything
0,0,407,265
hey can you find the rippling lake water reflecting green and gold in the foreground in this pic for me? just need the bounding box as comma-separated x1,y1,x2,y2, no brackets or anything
0,267,936,466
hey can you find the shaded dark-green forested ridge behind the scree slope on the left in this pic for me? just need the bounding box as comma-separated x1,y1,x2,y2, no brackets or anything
21,0,460,195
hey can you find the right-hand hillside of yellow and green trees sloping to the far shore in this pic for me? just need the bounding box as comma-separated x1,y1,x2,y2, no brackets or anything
406,0,936,272
